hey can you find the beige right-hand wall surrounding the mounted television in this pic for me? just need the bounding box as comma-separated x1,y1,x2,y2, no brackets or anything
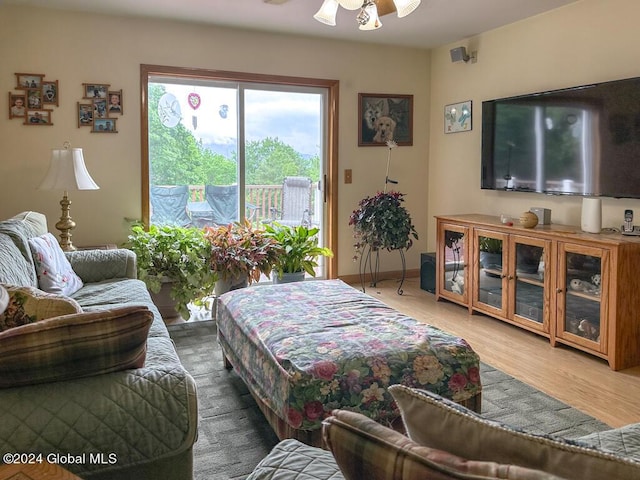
427,0,640,250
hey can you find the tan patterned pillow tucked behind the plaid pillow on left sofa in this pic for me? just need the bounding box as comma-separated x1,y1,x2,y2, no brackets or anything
0,285,82,332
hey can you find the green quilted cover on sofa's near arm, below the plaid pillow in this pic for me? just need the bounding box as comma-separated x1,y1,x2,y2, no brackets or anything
0,337,197,477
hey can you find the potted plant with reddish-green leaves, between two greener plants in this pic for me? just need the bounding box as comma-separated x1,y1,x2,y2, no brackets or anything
204,220,282,295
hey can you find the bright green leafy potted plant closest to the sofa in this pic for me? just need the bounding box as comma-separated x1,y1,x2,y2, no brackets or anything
125,224,216,320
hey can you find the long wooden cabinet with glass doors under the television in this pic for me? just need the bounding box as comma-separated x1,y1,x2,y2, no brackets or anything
436,214,640,370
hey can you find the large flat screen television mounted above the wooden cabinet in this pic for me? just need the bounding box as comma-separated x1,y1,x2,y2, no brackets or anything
481,78,640,198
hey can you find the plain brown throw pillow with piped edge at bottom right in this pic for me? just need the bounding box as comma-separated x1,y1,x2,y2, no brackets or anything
389,385,640,480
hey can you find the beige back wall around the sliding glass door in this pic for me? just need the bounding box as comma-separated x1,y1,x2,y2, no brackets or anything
0,6,430,275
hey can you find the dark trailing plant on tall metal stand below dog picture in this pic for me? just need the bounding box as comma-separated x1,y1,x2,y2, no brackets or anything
349,192,418,257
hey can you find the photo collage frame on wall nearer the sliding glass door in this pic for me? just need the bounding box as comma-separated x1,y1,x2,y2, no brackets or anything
77,83,124,133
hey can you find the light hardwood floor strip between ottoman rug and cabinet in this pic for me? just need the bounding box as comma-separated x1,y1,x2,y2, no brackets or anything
353,278,640,427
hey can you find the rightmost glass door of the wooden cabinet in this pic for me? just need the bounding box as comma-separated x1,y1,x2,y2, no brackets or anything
557,247,608,353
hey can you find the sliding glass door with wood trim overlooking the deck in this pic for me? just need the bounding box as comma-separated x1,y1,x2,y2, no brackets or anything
143,63,332,278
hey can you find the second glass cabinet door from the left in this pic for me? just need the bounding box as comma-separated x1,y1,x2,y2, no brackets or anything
474,230,506,310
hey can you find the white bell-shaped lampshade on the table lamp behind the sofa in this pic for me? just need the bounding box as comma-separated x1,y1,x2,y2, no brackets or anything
38,148,100,191
